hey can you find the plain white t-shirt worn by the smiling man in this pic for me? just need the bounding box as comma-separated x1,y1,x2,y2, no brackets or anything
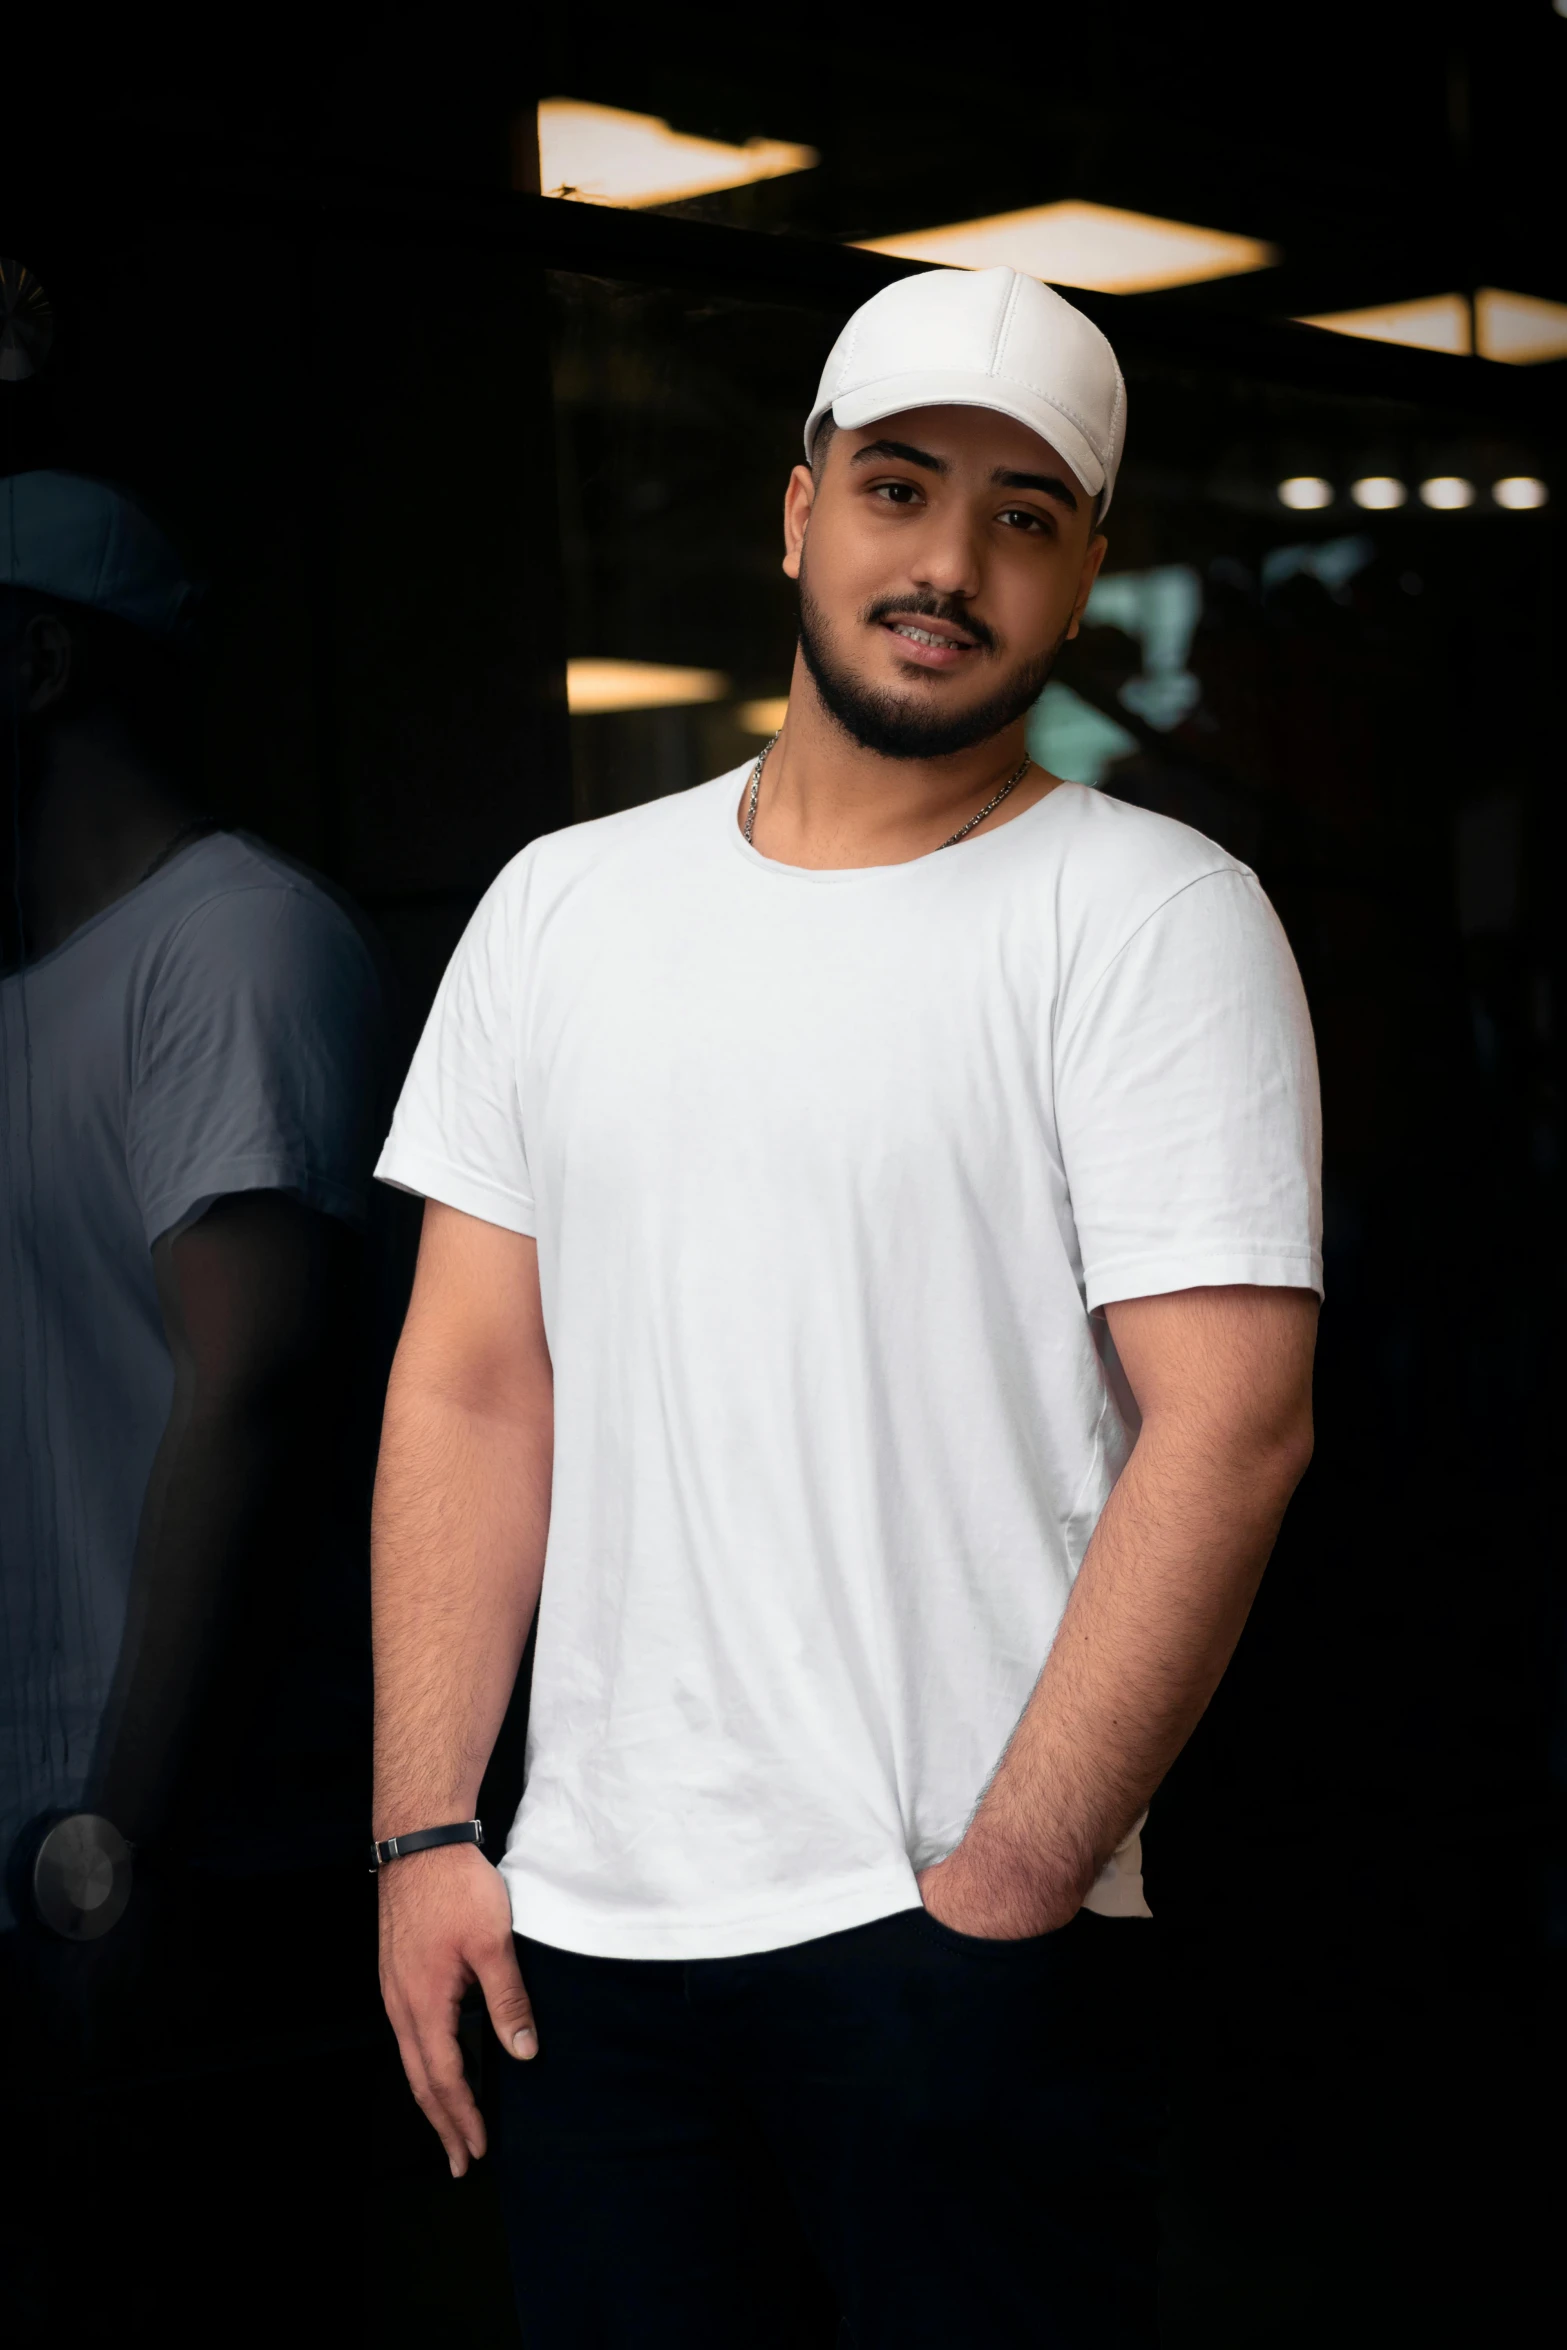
378,771,1320,1958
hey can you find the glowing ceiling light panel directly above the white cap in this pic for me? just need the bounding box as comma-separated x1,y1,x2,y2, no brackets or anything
865,202,1278,294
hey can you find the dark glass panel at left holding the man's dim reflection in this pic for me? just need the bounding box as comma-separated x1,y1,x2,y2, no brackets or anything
0,195,569,2341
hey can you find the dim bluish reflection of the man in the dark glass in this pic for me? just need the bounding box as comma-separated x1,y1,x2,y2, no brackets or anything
0,472,381,1967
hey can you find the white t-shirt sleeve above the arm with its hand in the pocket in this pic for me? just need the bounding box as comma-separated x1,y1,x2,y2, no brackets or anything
1055,867,1323,1311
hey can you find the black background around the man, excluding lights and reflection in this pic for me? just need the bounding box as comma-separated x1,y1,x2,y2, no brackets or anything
0,0,1567,2350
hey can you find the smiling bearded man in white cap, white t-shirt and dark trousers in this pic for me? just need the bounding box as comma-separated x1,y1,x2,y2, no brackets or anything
374,270,1320,2350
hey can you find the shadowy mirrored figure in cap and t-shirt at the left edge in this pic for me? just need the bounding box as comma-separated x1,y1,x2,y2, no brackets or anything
0,472,383,2322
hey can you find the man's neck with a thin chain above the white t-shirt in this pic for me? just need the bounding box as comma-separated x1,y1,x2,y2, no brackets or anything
738,653,1057,872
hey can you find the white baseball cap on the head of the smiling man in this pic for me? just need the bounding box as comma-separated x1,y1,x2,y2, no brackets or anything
806,268,1125,515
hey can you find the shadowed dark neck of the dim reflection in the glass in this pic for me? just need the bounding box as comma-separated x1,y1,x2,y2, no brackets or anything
19,721,190,961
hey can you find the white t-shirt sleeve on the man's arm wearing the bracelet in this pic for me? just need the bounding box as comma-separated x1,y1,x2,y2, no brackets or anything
376,851,538,1236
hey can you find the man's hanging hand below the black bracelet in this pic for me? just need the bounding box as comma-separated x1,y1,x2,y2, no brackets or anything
381,1845,538,2178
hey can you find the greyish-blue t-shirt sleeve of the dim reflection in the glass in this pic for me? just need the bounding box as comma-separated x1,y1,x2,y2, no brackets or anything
127,881,385,1246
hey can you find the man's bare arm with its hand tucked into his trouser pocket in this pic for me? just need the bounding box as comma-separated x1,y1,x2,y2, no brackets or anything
919,1288,1318,1939
